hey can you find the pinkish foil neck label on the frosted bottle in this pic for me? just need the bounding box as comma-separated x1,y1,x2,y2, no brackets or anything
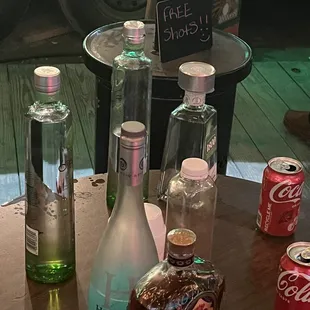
119,146,146,186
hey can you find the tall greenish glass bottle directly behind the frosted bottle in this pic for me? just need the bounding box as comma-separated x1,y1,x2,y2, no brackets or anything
107,21,152,208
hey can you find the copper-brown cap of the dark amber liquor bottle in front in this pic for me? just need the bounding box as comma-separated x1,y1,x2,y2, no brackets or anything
167,228,196,256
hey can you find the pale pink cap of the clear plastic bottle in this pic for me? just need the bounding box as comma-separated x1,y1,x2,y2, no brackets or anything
181,158,209,180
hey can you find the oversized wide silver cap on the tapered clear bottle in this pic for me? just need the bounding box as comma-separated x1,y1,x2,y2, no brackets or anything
178,61,215,94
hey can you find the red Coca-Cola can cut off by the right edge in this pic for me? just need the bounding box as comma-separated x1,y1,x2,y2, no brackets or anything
275,242,310,310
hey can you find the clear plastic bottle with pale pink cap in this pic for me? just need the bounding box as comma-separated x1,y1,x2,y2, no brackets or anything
166,158,217,260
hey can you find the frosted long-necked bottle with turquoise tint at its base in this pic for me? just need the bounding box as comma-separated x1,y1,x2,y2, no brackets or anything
88,121,158,310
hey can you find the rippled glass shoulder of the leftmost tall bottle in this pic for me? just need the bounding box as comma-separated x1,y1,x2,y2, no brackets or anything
26,101,72,123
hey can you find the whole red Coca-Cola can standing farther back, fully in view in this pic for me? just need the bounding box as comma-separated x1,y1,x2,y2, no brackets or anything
257,157,305,237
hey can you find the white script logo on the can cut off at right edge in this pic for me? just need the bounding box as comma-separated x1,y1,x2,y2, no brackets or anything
277,271,310,303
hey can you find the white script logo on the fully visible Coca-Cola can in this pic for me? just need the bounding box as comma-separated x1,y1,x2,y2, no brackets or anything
269,180,304,203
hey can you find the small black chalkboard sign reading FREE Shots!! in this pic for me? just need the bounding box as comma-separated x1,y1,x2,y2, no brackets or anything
156,0,213,62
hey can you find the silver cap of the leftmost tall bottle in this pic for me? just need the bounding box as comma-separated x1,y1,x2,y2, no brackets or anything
34,66,60,93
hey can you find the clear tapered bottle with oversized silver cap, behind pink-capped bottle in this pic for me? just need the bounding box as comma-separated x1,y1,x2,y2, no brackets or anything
158,62,217,201
